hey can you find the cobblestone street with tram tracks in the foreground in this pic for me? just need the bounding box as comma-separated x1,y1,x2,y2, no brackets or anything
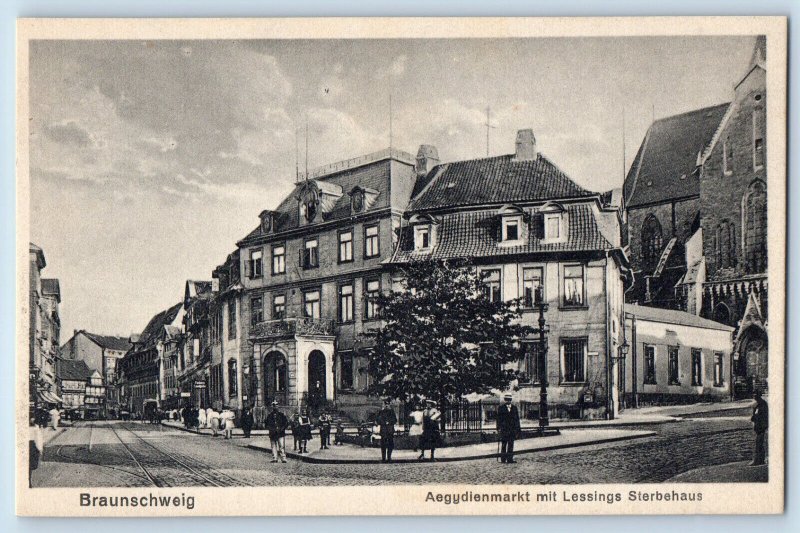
32,409,764,487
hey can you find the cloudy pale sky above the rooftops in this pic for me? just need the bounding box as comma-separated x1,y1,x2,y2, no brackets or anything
30,37,754,340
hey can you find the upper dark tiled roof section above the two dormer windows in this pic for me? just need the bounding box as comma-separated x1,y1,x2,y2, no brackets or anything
409,154,597,211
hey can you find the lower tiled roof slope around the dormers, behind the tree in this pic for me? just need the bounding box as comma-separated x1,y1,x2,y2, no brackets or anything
393,202,614,263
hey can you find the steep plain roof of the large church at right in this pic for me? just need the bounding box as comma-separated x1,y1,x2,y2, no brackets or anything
624,103,730,208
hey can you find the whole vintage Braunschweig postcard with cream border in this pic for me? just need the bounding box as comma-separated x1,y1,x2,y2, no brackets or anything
16,17,787,516
